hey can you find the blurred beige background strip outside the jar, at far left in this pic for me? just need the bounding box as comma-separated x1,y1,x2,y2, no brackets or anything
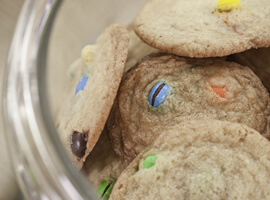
0,0,24,200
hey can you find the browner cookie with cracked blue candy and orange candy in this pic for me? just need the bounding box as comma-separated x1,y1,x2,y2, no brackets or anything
107,53,270,160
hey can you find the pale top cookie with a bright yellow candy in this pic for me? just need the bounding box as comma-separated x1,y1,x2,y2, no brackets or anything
135,0,270,57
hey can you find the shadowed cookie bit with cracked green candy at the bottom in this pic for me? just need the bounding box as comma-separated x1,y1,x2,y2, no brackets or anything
82,130,129,199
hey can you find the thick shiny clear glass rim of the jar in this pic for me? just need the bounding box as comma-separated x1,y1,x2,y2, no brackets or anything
2,0,96,199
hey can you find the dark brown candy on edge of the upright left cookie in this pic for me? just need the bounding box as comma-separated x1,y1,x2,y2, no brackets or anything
70,131,88,158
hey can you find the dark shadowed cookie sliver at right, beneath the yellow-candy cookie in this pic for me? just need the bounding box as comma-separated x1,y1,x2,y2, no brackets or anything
230,48,270,91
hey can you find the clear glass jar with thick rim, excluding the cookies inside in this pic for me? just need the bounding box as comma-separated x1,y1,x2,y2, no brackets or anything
3,0,145,200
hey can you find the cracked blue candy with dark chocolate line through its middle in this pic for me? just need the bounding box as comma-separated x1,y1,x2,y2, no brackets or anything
148,82,172,107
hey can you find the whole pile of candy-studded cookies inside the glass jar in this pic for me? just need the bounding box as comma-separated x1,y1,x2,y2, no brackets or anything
57,0,270,200
